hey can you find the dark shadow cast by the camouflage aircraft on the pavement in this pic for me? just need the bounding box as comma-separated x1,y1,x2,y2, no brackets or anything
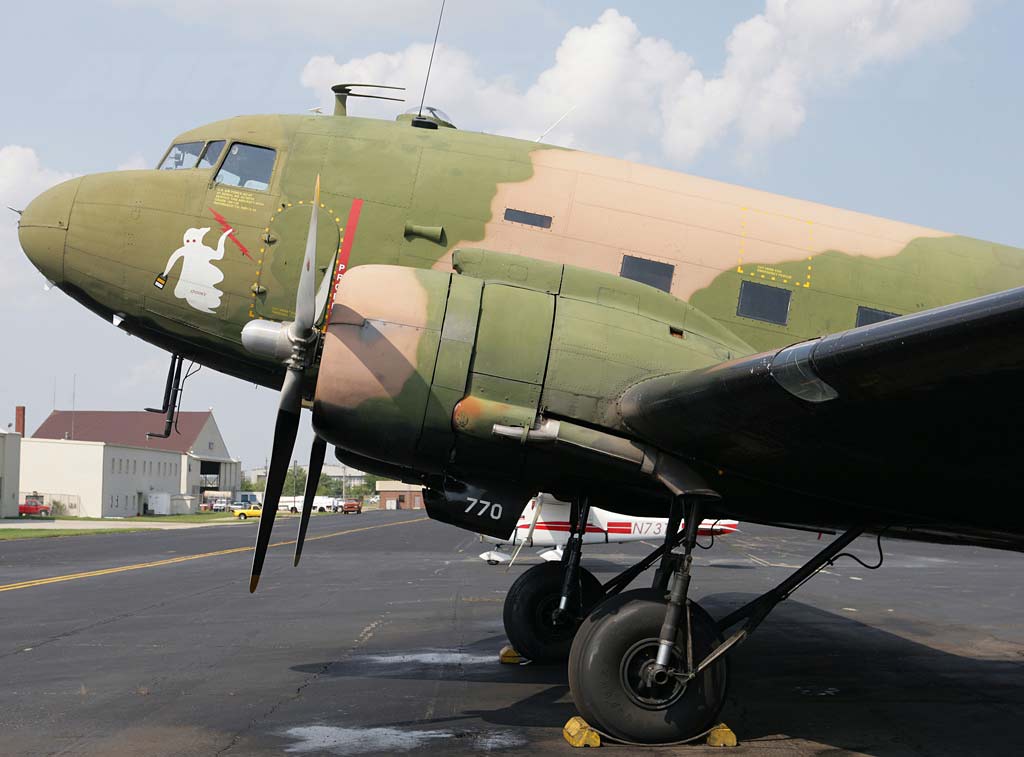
293,593,1024,757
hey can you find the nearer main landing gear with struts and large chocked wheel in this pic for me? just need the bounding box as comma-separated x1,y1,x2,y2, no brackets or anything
568,491,863,744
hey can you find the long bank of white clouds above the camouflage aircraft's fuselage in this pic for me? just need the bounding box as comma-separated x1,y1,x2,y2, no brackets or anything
301,0,974,164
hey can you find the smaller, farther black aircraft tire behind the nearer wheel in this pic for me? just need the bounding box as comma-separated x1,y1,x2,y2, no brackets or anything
503,562,602,664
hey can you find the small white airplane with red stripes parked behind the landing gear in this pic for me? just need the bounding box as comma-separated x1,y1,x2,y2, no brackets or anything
480,494,739,565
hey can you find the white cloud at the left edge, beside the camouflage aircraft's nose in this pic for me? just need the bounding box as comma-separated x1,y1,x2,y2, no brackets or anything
0,144,74,291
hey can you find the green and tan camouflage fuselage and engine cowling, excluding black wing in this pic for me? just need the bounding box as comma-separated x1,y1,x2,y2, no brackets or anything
20,116,1024,524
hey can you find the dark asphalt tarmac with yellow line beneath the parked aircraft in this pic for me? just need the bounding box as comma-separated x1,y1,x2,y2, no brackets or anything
0,512,1024,756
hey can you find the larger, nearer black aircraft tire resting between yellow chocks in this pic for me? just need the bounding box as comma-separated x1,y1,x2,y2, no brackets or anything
568,589,728,744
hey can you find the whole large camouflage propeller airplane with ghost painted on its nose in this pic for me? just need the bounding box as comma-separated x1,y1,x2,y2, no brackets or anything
18,79,1024,744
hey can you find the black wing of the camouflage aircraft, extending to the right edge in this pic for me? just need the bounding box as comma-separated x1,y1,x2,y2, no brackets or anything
620,288,1024,549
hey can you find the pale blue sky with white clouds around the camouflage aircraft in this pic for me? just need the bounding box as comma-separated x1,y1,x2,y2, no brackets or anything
0,0,1024,473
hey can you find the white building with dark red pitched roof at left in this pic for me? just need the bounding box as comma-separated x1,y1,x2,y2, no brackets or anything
20,411,241,517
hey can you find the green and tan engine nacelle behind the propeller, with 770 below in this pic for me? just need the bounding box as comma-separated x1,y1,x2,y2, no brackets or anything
313,250,752,538
